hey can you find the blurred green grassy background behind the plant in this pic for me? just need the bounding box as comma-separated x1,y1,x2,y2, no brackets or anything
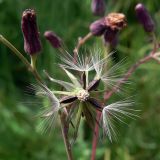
0,0,160,160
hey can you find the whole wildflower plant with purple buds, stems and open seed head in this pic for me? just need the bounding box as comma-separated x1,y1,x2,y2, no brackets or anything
0,1,160,160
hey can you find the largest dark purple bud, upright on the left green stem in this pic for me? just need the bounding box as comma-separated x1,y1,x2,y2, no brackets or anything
21,9,42,55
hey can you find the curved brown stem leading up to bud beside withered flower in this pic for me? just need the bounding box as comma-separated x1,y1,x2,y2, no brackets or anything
73,32,93,63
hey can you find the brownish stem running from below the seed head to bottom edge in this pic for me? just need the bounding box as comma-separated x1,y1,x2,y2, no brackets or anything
60,111,73,160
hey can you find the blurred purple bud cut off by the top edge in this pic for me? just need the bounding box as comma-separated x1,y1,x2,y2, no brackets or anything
91,0,106,16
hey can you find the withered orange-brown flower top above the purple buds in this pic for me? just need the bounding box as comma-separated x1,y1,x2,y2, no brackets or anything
105,13,127,31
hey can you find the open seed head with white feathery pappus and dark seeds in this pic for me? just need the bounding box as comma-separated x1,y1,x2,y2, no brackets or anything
35,51,139,141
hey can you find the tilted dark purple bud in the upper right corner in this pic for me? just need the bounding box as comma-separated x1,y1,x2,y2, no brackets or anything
135,3,154,32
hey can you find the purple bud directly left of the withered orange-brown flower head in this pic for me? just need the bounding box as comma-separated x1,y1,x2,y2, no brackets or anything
90,18,106,36
